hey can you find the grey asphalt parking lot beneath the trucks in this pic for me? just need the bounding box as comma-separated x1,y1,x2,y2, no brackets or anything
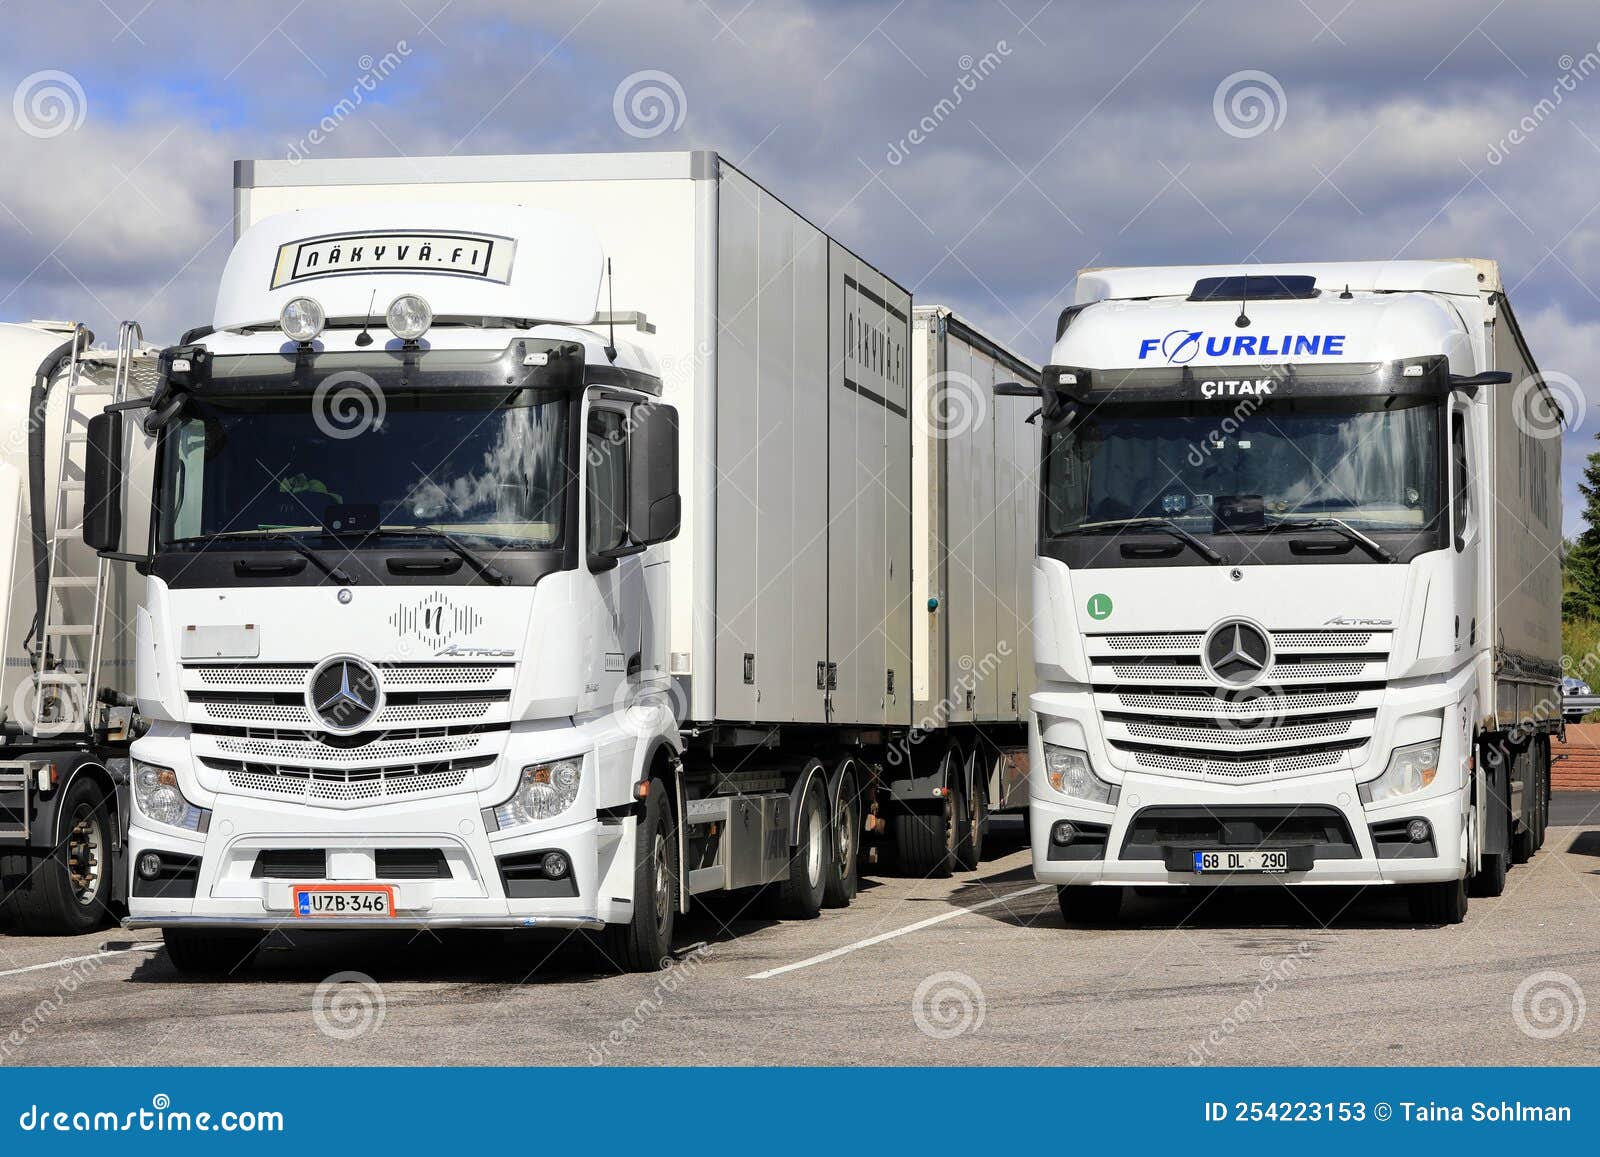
0,794,1600,1066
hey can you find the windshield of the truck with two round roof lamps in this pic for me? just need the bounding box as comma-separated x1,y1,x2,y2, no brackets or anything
158,389,571,550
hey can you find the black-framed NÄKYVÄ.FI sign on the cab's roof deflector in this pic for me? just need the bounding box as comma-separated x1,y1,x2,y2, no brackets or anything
272,229,517,290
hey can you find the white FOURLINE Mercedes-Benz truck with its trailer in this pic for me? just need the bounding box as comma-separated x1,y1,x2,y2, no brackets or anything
1000,261,1562,923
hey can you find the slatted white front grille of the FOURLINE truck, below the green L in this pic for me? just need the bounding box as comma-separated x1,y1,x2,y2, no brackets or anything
1085,629,1390,783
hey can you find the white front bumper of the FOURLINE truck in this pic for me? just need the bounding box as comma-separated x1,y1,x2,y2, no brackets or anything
1030,771,1467,887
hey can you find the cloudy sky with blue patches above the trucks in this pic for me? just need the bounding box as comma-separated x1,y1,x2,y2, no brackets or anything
9,0,1600,531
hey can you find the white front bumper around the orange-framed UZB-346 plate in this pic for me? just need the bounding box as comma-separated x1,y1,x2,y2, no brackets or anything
123,792,635,928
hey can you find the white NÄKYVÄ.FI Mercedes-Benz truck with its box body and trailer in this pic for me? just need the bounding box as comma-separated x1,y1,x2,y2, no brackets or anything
85,152,1037,971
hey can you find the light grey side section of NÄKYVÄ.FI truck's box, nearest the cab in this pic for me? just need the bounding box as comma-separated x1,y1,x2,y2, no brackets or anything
717,168,827,722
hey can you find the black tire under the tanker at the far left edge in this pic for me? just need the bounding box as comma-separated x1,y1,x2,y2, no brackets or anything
5,775,115,936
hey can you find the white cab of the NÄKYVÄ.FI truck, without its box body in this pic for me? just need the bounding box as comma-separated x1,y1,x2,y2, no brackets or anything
85,205,680,971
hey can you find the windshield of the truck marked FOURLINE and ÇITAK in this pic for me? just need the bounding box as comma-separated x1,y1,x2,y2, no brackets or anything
1045,397,1442,538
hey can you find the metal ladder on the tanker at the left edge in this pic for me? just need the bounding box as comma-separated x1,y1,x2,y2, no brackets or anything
34,322,144,735
